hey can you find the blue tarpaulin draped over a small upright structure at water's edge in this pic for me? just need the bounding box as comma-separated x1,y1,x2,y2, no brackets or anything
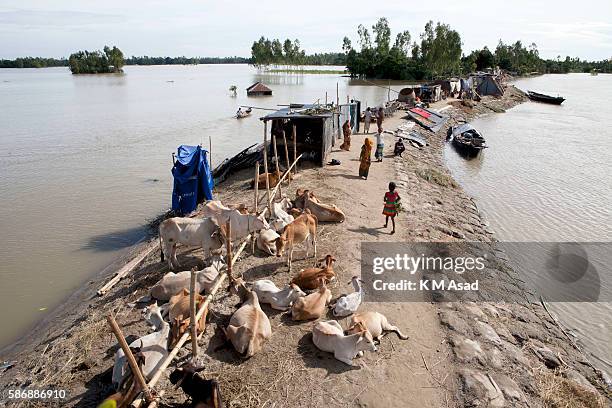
172,145,214,215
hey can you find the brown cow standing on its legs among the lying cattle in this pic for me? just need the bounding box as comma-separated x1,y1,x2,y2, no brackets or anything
276,210,317,272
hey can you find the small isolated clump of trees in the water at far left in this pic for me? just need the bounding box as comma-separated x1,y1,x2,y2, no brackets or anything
68,46,125,74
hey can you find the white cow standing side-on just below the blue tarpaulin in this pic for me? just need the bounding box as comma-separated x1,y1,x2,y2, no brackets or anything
159,217,224,269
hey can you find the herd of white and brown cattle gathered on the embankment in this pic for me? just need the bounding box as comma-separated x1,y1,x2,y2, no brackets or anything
103,189,407,407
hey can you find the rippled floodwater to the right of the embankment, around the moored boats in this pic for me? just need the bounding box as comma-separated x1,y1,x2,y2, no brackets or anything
445,74,612,373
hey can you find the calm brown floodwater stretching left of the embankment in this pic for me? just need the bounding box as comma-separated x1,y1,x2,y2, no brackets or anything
0,65,412,348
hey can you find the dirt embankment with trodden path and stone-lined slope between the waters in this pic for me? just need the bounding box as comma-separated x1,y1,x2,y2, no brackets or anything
0,84,604,407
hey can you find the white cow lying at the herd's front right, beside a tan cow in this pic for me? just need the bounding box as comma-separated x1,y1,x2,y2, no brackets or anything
312,320,377,366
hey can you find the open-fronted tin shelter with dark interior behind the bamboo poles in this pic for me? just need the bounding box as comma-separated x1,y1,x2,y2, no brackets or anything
261,104,335,166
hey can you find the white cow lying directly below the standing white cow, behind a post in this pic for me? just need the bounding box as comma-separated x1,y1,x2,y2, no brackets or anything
150,257,225,301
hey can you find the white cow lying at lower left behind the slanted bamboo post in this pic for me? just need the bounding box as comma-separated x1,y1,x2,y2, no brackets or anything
112,304,170,388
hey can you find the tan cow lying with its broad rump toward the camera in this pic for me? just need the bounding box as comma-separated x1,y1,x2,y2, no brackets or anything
223,291,272,358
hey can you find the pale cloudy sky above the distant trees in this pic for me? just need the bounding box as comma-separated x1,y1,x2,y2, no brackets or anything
0,0,612,60
